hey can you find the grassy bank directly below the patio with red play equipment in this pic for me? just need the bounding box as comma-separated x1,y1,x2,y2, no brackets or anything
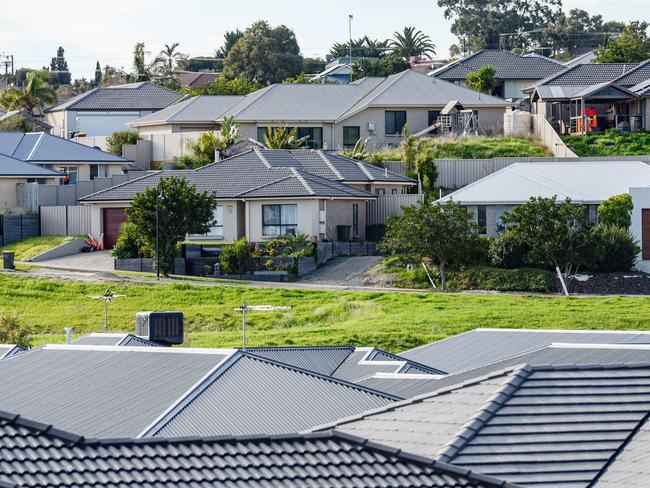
562,130,650,156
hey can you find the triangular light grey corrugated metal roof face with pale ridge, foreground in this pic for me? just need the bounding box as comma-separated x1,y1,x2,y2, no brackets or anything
142,351,399,437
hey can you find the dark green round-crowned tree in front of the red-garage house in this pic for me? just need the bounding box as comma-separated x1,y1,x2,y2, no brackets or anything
126,176,217,276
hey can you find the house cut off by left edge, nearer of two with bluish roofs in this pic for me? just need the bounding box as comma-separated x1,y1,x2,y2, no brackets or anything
0,154,63,213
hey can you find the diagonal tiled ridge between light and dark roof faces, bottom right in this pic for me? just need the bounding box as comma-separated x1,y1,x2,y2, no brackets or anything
436,364,533,462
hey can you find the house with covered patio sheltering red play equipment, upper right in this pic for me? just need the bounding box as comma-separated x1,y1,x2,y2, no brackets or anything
524,60,650,135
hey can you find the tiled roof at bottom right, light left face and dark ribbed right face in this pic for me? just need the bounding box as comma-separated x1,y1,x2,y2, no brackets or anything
330,364,650,488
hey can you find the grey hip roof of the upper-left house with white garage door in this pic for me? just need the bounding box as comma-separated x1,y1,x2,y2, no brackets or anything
45,81,184,113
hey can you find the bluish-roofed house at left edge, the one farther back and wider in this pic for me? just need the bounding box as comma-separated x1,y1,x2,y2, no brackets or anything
0,132,131,185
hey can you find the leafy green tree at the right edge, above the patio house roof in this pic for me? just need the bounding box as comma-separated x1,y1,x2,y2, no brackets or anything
595,20,650,63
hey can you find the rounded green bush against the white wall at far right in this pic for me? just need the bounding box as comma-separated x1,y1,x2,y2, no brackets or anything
592,224,639,272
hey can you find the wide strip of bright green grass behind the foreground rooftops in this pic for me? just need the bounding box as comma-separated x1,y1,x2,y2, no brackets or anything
0,274,650,352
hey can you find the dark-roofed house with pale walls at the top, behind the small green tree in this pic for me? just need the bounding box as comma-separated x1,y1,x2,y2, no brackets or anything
429,49,566,99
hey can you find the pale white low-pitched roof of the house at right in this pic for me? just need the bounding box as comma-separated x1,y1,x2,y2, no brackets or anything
438,161,650,205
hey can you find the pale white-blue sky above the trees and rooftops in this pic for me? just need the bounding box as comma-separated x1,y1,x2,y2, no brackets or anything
0,0,650,79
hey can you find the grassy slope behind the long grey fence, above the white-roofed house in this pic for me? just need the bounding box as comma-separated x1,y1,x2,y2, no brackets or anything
373,136,551,162
